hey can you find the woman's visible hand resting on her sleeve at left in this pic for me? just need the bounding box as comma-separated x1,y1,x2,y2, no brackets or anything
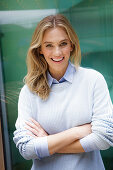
25,118,48,137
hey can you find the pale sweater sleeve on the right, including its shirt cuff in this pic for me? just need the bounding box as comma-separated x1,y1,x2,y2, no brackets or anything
80,73,113,152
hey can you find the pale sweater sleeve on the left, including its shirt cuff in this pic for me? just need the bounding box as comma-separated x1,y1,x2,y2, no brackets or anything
13,85,49,160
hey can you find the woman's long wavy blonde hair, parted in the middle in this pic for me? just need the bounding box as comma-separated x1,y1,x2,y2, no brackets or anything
25,14,81,100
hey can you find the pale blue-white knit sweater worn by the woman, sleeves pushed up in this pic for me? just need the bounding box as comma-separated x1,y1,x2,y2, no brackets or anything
14,67,113,170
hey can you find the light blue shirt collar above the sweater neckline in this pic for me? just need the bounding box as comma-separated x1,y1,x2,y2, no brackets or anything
47,61,76,87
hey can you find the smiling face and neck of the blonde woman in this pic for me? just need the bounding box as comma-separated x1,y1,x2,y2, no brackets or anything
40,27,72,78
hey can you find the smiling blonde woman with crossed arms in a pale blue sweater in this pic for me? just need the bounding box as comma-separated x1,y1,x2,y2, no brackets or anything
14,14,113,170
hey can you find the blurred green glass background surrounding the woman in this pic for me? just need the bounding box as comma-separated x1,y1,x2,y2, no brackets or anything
0,0,113,170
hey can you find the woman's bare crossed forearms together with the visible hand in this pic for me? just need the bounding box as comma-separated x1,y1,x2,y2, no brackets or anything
26,119,91,155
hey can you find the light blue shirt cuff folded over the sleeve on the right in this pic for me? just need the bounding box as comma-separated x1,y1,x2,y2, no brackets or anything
80,134,99,152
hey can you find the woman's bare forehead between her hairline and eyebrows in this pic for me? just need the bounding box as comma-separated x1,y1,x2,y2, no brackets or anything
42,27,69,42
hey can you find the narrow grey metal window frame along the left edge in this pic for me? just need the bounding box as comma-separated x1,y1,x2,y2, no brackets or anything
0,34,12,170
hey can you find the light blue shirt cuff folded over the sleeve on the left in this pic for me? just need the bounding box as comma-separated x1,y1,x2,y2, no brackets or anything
34,136,50,159
